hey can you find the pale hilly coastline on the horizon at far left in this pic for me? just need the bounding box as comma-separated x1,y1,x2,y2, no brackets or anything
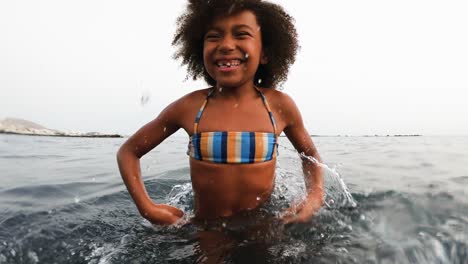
0,118,123,138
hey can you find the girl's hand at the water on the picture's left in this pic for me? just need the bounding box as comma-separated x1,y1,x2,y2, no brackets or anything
140,204,184,225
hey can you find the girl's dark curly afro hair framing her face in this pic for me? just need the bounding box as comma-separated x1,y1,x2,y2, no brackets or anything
172,0,299,88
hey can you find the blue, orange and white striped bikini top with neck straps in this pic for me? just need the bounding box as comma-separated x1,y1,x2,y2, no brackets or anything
187,87,278,163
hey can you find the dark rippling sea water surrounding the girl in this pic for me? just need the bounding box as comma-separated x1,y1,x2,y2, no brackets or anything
0,135,468,264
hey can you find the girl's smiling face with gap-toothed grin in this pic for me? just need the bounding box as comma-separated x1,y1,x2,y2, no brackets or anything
203,10,266,87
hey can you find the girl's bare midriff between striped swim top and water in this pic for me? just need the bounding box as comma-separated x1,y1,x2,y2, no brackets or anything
190,159,276,219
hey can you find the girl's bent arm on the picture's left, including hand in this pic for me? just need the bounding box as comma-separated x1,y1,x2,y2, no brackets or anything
117,101,184,225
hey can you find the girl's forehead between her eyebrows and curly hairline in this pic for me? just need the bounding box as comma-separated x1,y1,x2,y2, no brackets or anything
208,10,259,29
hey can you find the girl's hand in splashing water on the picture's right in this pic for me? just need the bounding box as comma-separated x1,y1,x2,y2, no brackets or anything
282,195,323,224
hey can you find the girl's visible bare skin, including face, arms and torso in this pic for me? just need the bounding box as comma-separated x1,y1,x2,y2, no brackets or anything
117,11,323,224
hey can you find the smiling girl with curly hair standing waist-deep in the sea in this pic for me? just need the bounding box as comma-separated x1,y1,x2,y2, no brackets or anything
117,0,323,225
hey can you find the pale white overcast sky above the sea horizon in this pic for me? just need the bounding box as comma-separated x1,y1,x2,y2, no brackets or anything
0,0,468,135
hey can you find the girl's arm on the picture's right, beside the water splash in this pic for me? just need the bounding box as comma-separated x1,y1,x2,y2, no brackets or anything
282,95,324,223
